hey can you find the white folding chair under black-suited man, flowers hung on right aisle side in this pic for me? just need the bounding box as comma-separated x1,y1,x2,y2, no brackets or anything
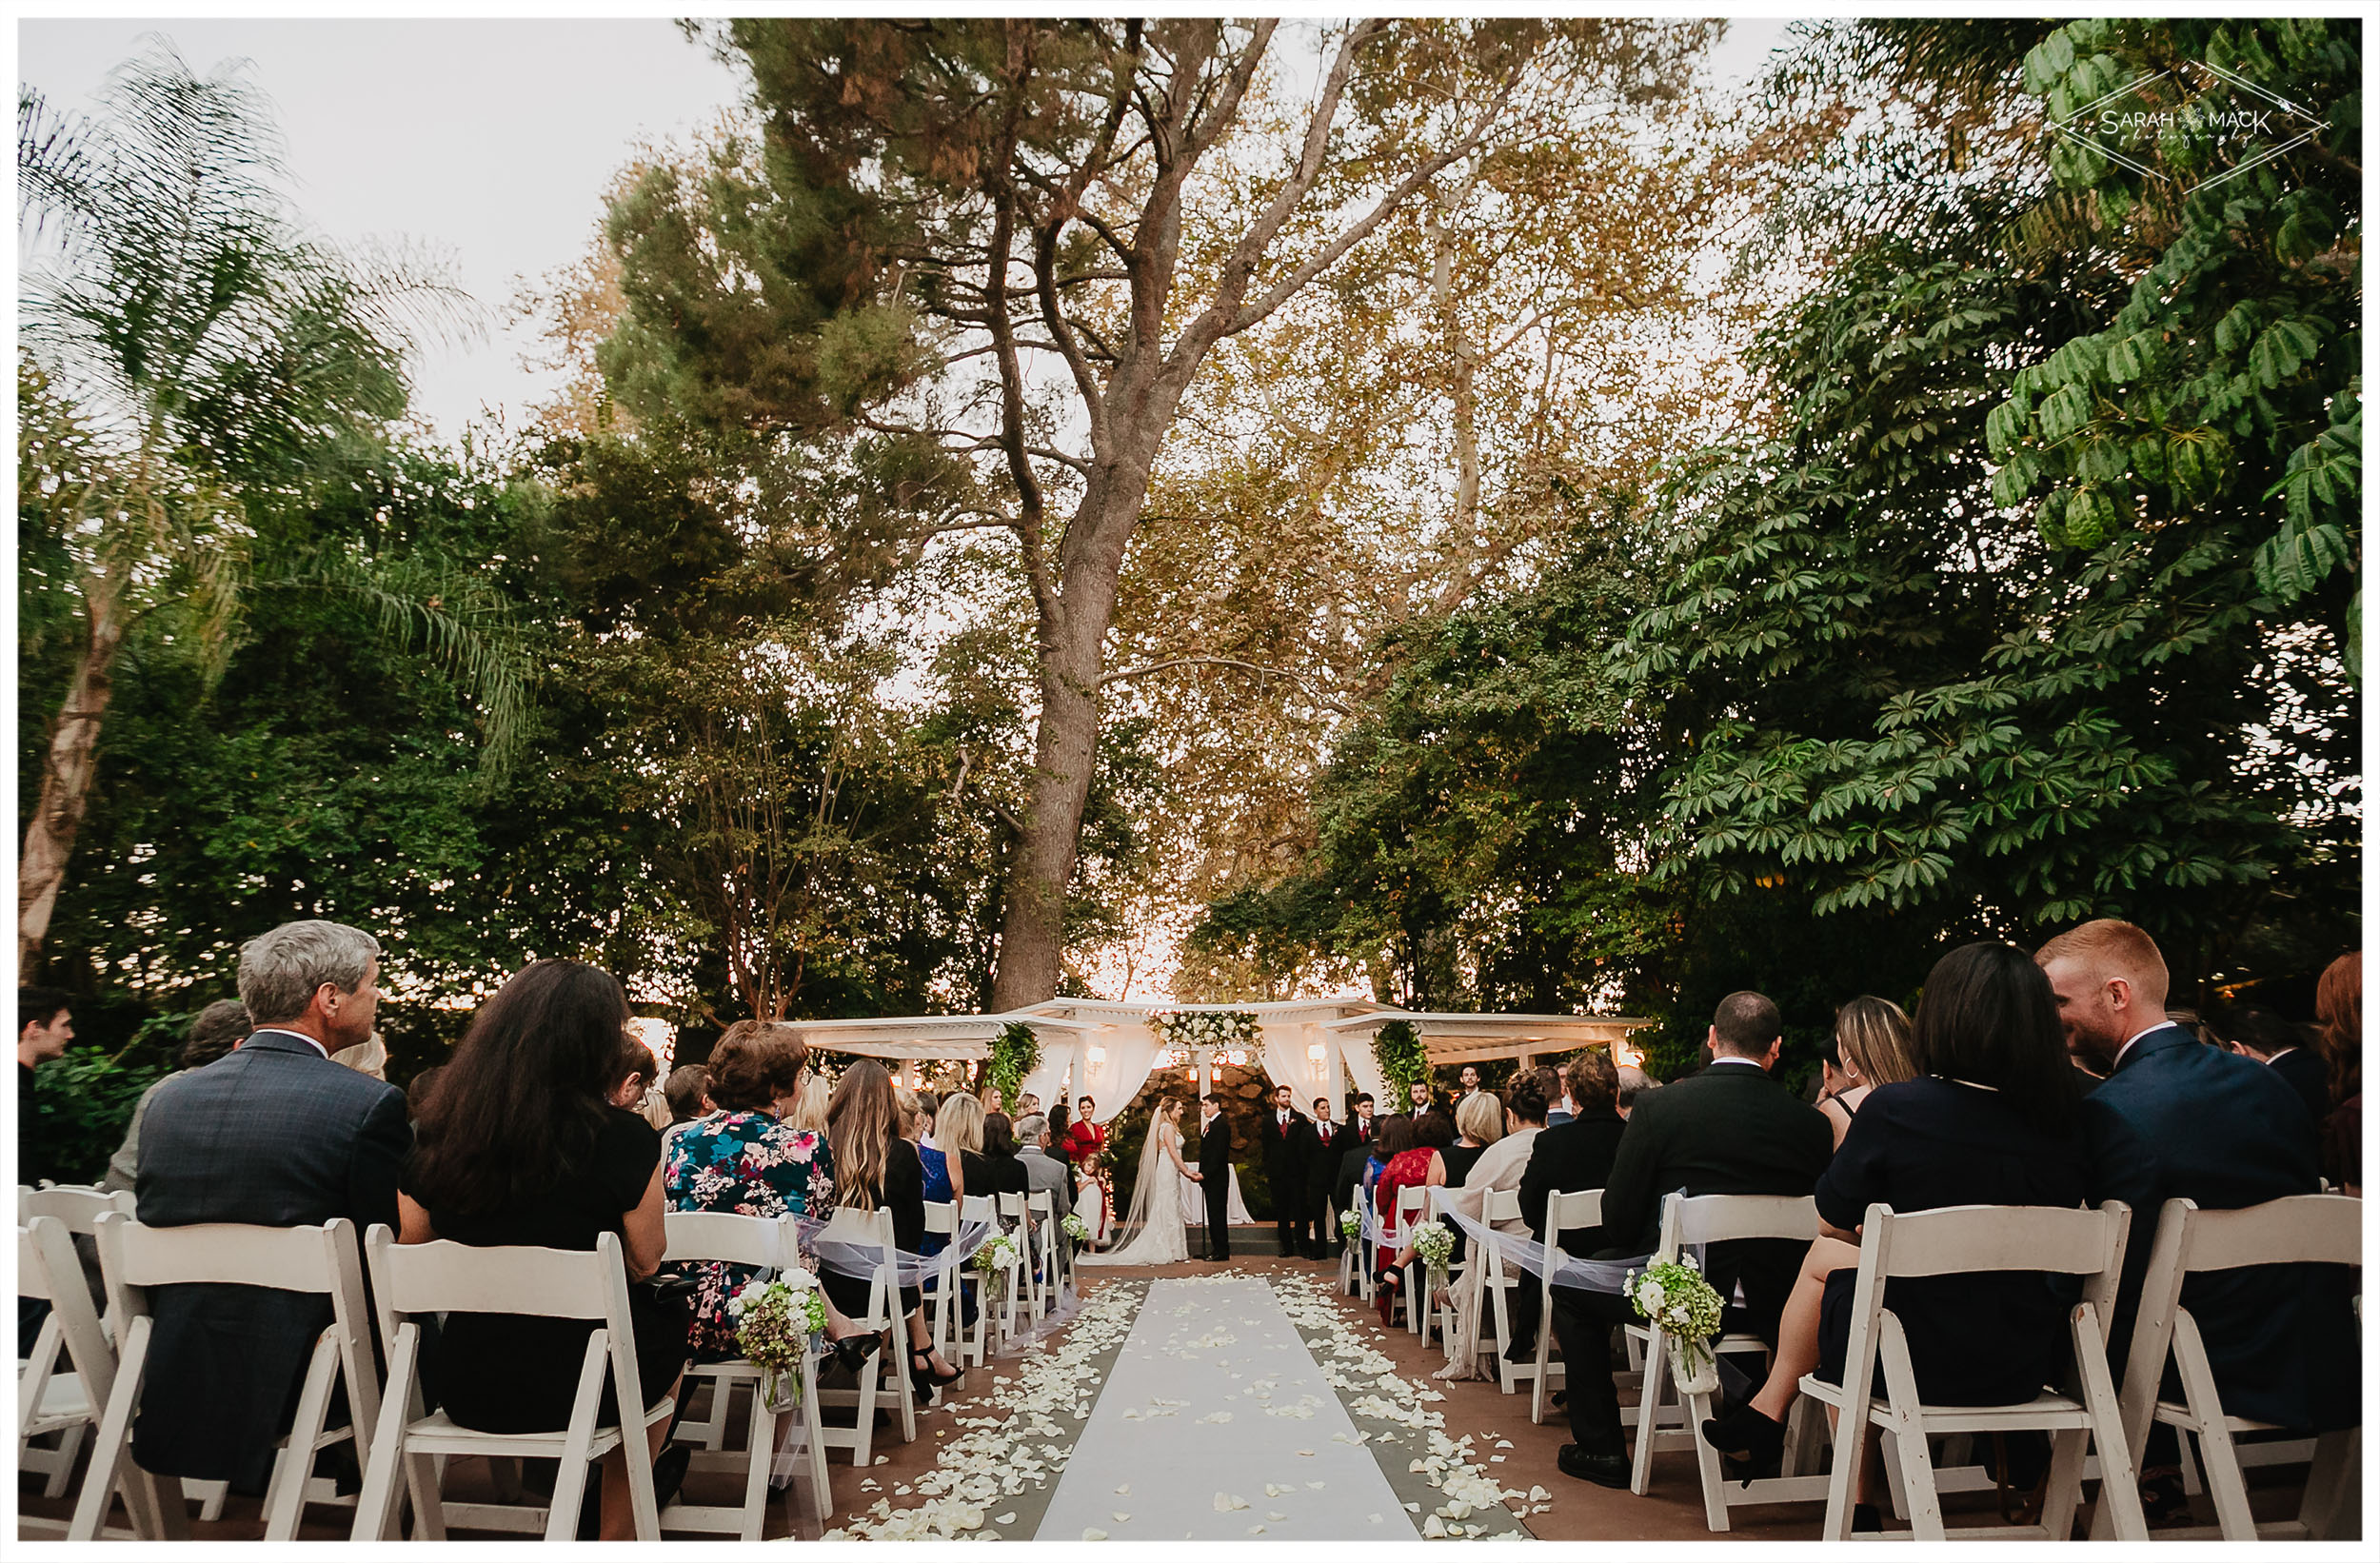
1623,1195,1826,1533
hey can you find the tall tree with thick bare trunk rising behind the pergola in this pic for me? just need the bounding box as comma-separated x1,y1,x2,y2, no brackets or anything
607,19,1695,1009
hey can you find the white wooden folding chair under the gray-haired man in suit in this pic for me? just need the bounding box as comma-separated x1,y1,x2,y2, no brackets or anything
67,1211,381,1542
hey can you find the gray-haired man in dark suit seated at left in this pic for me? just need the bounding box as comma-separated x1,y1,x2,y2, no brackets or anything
133,923,414,1494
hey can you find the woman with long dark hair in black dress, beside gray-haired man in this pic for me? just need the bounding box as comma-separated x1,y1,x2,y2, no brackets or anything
398,961,688,1539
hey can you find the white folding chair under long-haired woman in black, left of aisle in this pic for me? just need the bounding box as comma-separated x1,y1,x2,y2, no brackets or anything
355,1225,676,1542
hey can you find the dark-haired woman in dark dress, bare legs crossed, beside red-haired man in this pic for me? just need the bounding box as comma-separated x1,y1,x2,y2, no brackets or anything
1702,942,2083,1528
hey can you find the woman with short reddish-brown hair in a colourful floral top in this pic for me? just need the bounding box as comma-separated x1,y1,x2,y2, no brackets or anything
662,1020,836,1363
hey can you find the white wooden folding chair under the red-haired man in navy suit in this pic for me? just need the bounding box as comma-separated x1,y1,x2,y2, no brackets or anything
2092,1195,2364,1542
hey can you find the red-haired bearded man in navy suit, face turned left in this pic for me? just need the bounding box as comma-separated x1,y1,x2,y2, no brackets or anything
2035,919,2364,1509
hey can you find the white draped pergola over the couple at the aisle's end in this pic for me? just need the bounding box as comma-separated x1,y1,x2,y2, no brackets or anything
785,999,1652,1123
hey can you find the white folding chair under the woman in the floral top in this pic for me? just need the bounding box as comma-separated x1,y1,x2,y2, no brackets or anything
662,1211,831,1542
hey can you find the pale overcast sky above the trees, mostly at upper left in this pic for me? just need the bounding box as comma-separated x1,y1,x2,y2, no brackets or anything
17,16,1785,438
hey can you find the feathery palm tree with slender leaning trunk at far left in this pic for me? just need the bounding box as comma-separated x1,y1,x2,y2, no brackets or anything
17,43,519,963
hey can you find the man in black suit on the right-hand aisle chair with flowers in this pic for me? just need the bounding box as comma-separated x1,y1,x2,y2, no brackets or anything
1540,992,1835,1487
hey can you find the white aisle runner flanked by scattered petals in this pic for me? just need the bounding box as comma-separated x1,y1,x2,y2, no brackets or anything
1036,1276,1417,1542
